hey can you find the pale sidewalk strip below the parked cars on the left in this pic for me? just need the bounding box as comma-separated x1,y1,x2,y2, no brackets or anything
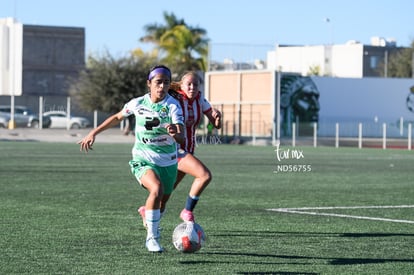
0,128,134,144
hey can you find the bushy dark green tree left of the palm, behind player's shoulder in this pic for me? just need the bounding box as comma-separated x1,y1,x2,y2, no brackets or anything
69,53,158,113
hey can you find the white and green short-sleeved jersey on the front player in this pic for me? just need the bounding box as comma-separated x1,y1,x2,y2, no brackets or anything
122,94,184,167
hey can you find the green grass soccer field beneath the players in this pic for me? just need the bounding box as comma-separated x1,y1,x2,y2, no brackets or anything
0,142,414,274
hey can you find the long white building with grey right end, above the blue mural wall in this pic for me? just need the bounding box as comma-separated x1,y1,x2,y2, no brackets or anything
267,37,402,78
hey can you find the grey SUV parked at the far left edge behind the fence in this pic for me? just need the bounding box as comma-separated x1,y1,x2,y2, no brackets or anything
0,105,51,128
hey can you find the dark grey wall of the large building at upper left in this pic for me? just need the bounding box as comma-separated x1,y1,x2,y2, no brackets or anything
23,25,85,96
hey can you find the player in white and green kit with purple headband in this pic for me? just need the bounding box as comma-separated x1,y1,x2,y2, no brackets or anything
78,65,185,252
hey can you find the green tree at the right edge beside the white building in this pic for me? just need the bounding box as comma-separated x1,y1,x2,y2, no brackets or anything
382,41,414,78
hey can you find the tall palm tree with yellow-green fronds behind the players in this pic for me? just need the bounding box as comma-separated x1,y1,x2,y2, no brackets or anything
140,12,209,73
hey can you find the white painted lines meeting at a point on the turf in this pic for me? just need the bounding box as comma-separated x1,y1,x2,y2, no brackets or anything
266,205,414,224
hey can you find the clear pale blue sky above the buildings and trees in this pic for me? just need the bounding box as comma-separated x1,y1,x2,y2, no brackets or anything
0,0,414,60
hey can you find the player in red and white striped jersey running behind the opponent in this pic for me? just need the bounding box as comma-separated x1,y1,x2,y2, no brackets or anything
138,72,221,225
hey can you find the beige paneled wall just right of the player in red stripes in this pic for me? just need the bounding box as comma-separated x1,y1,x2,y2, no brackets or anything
204,70,276,137
